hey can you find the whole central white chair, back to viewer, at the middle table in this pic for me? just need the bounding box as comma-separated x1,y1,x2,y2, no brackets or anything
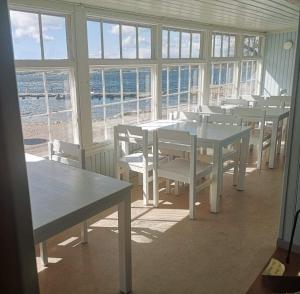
153,129,212,219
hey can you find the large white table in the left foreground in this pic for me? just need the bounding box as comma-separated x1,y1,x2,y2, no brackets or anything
26,154,132,293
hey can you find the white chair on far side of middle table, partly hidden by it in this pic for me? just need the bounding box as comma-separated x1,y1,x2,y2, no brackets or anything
206,114,242,194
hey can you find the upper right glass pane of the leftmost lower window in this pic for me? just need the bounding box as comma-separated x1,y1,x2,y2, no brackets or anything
45,71,72,112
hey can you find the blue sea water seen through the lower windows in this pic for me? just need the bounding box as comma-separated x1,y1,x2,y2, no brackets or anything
17,66,216,120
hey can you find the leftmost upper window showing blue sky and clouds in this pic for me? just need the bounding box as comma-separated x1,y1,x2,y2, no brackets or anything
10,10,68,60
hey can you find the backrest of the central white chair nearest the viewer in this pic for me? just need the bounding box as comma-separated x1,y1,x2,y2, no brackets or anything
153,129,197,177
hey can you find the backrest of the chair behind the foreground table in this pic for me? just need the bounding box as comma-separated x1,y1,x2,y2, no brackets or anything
48,140,85,169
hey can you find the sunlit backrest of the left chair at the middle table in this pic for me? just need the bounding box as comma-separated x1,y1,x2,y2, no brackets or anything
114,125,148,161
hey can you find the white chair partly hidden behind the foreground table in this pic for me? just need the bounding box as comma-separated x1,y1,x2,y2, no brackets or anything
40,140,88,265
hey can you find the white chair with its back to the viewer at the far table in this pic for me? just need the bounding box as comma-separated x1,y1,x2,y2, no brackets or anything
234,108,271,170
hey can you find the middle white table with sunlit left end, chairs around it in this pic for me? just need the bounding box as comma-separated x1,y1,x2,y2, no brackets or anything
139,120,250,213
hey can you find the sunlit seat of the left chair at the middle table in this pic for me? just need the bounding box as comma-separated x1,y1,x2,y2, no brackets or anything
119,152,166,171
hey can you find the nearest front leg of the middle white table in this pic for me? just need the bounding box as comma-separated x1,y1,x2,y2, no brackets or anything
210,144,223,213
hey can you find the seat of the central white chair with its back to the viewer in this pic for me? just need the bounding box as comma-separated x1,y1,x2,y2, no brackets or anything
158,158,212,183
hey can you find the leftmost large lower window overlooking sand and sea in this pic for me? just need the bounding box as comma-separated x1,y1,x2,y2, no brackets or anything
17,71,73,156
